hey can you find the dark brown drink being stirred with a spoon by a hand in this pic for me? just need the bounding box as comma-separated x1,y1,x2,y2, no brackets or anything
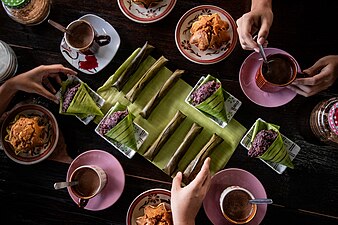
262,54,296,85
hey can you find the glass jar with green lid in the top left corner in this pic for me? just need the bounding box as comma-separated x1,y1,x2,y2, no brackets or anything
1,0,51,26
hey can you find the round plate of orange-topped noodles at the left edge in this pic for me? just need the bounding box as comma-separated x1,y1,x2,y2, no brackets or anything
1,104,59,165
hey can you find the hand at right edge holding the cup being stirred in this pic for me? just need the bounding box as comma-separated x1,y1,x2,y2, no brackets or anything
288,55,338,97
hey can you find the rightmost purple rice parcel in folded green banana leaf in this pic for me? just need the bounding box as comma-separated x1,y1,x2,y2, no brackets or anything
248,120,294,169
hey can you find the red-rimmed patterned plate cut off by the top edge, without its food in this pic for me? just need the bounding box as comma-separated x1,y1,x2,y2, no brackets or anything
117,0,176,23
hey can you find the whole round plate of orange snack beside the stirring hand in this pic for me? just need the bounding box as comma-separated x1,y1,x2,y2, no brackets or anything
175,5,238,64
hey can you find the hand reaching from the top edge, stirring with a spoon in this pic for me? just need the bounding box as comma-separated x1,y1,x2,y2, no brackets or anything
236,0,273,52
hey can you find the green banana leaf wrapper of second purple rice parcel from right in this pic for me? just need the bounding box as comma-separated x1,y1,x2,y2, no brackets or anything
191,75,229,122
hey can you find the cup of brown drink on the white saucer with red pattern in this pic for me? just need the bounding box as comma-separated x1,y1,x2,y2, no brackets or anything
64,19,111,55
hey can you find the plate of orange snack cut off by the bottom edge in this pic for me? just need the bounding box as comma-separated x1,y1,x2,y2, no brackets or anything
126,188,173,225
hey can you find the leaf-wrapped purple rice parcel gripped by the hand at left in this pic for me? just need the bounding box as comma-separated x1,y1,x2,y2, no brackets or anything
59,80,103,118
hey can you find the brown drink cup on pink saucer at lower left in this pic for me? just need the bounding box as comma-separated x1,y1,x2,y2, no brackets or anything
69,165,107,208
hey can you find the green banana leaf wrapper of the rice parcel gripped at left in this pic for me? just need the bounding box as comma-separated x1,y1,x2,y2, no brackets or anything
59,80,103,118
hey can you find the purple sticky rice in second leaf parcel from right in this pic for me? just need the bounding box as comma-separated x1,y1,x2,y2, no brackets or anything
190,80,221,105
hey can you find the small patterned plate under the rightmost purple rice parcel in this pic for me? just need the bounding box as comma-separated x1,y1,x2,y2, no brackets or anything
241,118,300,174
